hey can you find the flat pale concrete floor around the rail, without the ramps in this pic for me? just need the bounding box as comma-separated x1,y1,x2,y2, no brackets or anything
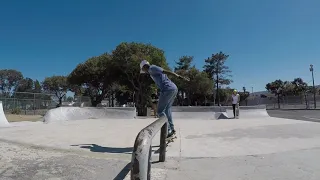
0,118,320,180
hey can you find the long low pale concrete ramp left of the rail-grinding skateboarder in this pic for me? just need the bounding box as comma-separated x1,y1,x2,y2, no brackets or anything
44,107,136,123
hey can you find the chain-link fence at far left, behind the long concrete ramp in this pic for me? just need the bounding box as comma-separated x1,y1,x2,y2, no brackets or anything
0,92,91,115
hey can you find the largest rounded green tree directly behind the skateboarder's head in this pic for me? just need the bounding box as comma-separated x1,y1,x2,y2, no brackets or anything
112,42,168,116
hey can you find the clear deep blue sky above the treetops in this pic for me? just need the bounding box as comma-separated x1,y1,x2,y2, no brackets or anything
0,0,320,91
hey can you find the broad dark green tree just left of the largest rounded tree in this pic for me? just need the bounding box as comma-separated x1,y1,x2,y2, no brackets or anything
68,53,118,107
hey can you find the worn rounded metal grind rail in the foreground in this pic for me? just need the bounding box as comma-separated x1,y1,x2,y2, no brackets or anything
131,115,168,180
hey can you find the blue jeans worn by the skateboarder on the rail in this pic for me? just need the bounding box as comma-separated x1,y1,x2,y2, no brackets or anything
158,89,178,133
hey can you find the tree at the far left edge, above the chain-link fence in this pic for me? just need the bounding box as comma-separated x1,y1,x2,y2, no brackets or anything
0,69,23,96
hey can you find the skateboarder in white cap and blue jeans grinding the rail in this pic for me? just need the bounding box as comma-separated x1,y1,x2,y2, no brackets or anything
140,60,189,138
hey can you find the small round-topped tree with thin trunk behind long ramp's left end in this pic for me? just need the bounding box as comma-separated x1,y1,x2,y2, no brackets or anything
42,76,69,106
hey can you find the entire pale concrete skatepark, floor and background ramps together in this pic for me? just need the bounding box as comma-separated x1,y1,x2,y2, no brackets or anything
0,100,320,180
